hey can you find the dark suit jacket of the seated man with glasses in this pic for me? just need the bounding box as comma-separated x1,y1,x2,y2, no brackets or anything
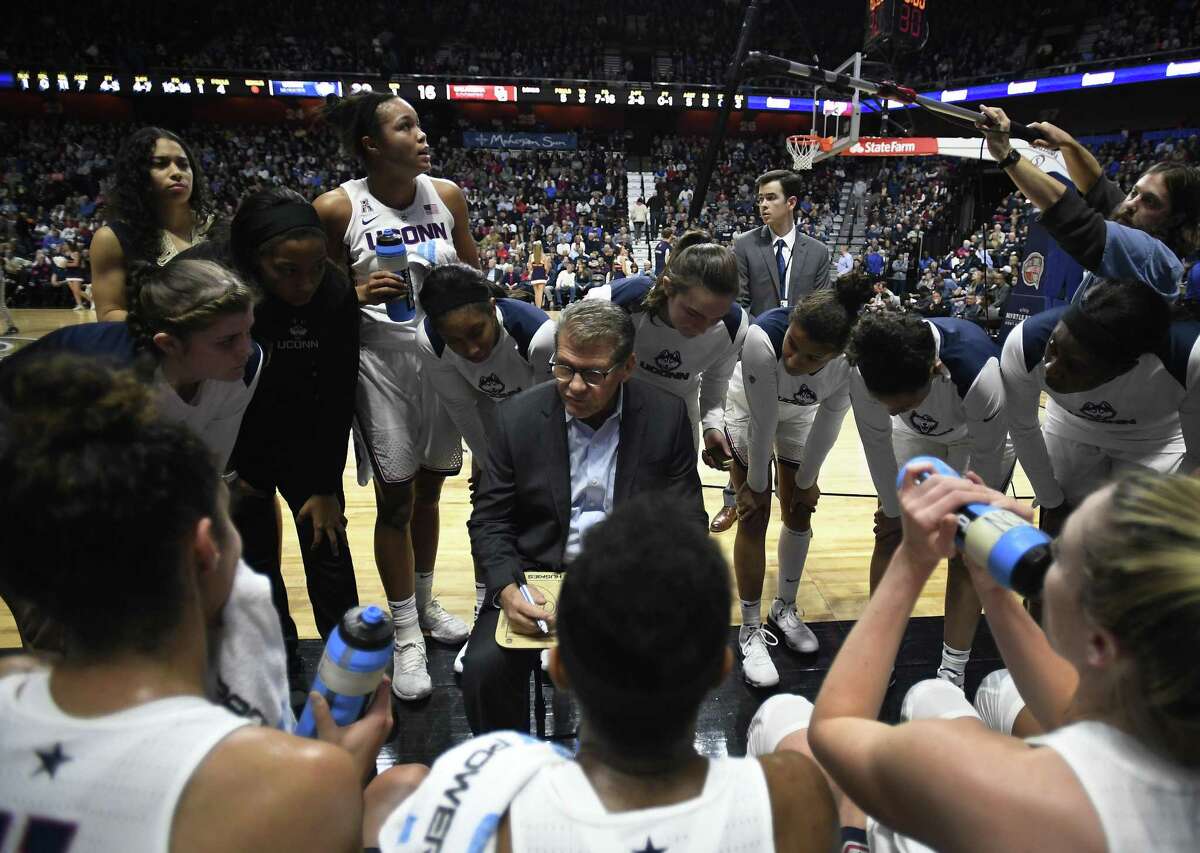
467,379,708,594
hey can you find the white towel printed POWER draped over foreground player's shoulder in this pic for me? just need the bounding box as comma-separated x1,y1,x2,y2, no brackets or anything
379,732,571,853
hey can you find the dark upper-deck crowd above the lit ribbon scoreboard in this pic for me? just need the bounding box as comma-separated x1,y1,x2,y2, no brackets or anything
0,0,1200,86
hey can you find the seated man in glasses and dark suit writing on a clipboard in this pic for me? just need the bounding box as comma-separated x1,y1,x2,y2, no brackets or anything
462,300,708,734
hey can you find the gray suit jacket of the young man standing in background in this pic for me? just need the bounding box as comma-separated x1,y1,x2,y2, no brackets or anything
733,226,830,319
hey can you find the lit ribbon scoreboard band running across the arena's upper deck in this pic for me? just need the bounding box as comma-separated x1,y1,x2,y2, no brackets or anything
0,59,1200,113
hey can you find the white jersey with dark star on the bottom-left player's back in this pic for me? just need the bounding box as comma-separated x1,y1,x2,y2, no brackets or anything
0,672,251,853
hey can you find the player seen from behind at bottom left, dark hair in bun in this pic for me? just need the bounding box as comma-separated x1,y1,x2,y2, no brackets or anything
0,355,398,853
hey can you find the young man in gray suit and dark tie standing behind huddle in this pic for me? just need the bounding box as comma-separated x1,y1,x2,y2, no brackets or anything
733,169,829,318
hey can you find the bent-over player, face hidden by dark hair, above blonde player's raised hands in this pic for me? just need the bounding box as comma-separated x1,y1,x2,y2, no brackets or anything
848,313,1015,686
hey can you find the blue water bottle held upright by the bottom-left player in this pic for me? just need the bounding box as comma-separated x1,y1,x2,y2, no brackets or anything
296,605,392,738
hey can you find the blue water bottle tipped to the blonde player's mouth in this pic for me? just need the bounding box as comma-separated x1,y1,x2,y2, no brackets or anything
896,456,1054,597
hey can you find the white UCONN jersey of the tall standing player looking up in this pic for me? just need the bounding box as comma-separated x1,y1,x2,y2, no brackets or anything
342,175,458,344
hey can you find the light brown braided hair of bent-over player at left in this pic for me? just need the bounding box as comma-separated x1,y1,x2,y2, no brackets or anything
126,258,257,348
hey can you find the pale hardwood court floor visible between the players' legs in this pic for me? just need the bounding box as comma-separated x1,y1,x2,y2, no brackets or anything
0,310,1032,648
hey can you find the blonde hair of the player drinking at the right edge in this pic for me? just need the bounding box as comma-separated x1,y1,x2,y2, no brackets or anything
1081,471,1200,767
